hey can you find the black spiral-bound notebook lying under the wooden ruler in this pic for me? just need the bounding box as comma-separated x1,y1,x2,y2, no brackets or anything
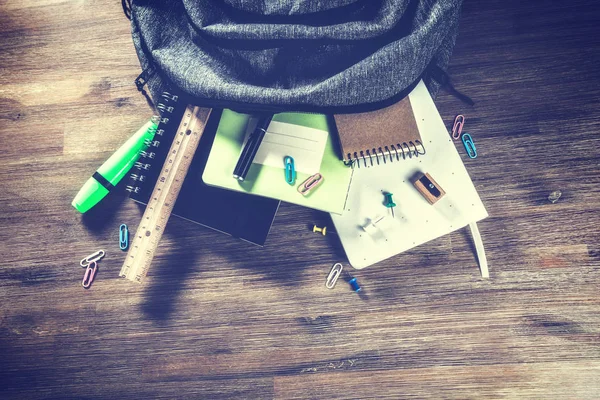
127,93,279,246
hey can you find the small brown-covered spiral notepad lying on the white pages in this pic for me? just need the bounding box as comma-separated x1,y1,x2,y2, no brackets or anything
334,97,425,164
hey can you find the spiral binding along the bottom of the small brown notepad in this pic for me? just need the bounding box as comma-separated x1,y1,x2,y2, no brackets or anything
345,140,425,168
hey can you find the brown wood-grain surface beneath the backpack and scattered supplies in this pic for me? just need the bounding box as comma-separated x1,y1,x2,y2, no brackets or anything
0,0,600,399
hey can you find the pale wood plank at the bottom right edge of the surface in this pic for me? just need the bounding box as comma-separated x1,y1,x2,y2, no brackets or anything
274,362,600,399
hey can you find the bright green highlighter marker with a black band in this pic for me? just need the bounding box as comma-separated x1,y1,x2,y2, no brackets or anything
71,121,157,213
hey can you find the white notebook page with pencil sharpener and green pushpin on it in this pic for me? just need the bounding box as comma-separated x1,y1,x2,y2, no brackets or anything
331,82,488,269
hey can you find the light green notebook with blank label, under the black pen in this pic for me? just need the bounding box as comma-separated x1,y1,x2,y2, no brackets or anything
202,110,352,214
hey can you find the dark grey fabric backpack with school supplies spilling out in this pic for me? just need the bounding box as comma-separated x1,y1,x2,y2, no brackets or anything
130,0,462,113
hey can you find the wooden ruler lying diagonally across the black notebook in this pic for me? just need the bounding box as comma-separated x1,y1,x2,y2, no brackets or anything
119,105,211,283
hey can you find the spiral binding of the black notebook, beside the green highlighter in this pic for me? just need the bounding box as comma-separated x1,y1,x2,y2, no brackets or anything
125,92,179,193
